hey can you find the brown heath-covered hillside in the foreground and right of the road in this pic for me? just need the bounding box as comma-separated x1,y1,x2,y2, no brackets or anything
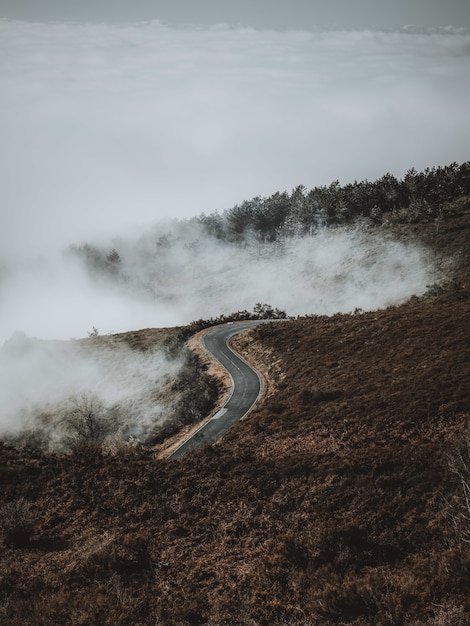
0,200,470,626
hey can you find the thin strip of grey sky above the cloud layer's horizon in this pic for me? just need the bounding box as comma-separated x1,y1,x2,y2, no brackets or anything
0,0,470,29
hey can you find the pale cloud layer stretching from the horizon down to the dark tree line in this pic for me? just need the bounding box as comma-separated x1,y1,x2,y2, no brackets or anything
0,20,470,258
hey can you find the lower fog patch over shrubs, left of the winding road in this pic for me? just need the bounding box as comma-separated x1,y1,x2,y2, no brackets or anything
0,333,181,450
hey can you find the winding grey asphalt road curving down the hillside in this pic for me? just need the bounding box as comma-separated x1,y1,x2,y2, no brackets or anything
168,321,263,459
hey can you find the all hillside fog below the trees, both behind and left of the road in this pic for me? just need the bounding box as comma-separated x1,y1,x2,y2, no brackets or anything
0,220,440,442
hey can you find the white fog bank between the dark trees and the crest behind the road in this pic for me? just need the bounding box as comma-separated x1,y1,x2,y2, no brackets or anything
2,220,439,339
